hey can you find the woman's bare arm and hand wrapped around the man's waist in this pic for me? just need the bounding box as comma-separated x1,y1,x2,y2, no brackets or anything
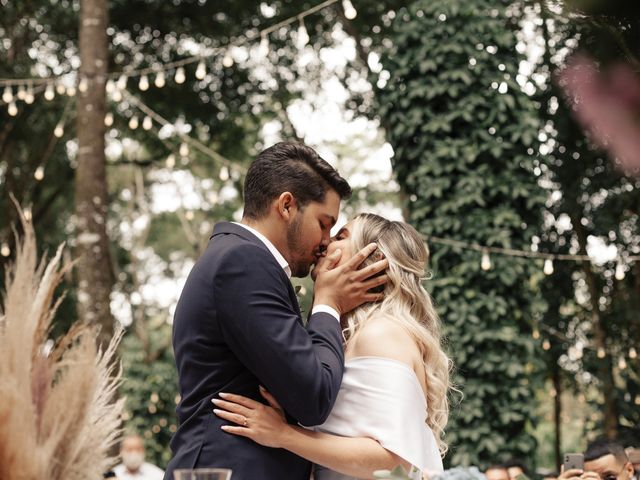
215,392,409,478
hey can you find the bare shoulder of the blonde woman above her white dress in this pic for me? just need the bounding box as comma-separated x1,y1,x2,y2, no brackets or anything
347,316,421,366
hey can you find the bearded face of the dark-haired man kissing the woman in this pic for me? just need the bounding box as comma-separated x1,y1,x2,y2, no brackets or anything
287,190,340,277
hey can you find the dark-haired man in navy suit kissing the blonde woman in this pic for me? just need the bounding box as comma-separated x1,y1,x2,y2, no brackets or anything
165,143,386,480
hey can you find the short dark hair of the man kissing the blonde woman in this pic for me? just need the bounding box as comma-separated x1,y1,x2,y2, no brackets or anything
243,142,351,220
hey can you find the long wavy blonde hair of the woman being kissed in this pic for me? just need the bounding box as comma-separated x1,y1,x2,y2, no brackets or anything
343,214,453,456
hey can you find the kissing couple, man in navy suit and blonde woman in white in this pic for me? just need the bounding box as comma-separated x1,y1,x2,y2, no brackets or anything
165,142,451,480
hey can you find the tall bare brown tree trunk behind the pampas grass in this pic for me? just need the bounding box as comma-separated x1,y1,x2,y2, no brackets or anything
75,0,114,345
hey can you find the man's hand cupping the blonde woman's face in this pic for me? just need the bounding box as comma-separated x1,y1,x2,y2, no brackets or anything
314,243,389,315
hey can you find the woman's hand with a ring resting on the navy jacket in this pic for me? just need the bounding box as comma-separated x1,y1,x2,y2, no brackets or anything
211,387,288,448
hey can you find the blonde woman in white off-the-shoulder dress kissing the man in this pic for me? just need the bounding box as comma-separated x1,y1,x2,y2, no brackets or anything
214,214,451,480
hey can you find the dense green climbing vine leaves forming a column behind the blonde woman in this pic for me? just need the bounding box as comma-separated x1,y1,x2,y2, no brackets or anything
376,0,545,466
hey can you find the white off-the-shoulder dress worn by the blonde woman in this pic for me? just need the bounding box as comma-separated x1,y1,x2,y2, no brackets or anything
314,357,442,480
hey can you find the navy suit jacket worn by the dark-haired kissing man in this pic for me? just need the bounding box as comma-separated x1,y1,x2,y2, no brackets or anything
165,222,344,480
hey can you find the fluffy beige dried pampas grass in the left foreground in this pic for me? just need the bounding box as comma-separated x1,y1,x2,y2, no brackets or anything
0,205,123,480
